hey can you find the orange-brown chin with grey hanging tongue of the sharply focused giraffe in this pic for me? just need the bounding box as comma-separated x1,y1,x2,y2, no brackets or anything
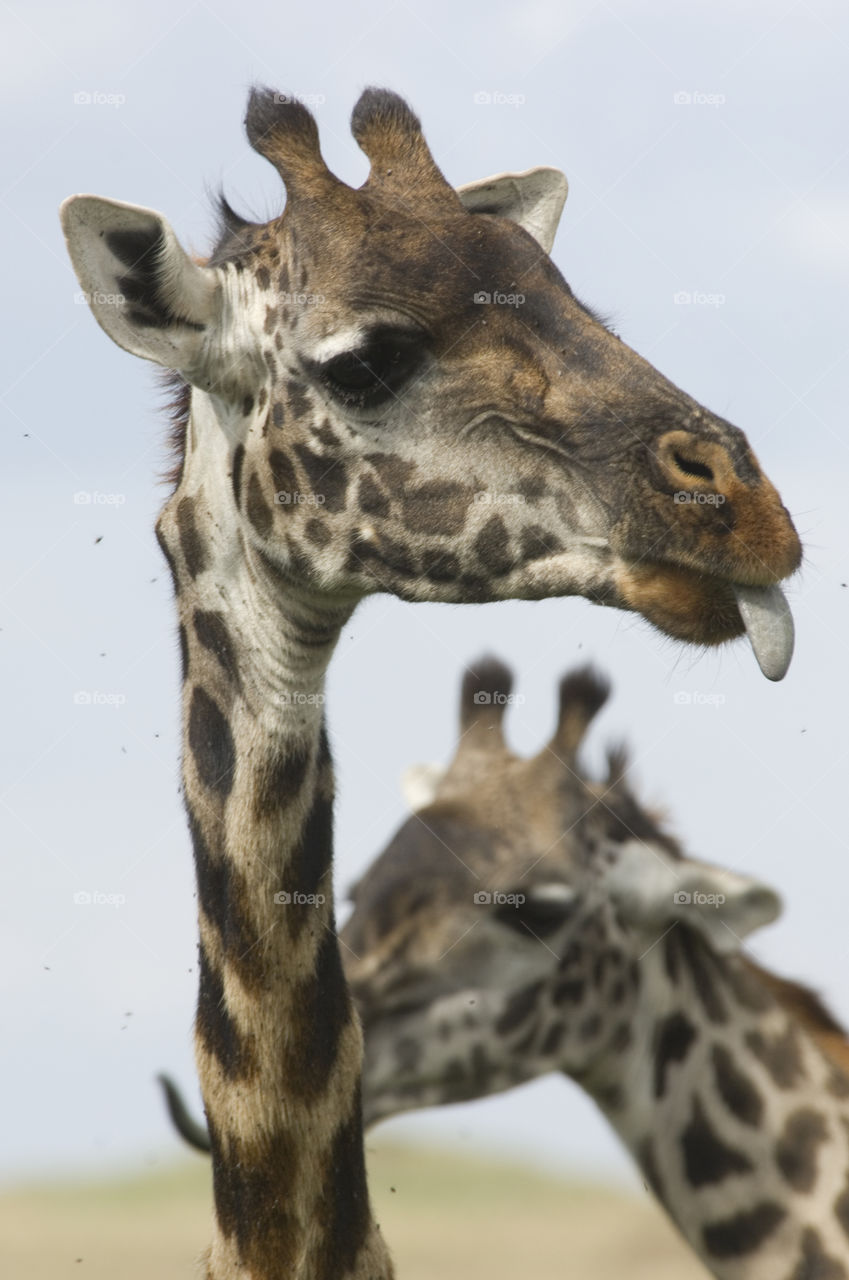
615,561,794,680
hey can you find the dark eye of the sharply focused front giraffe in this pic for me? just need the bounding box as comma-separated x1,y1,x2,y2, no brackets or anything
315,332,424,408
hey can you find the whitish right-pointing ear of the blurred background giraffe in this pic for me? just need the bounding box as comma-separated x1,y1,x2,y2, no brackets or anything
610,840,781,955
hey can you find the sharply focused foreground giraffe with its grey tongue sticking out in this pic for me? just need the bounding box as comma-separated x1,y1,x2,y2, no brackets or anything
61,88,800,1280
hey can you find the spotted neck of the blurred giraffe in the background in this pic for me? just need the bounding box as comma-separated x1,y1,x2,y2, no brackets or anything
581,928,849,1280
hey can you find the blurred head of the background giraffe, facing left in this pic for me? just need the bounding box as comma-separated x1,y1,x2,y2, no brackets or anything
342,660,779,1123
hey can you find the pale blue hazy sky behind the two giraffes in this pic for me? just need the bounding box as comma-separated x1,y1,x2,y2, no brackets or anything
0,0,849,1178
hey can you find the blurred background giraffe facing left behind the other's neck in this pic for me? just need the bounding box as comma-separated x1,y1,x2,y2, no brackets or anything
342,660,849,1280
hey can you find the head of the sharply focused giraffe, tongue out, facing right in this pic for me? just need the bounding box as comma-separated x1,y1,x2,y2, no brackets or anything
63,90,800,678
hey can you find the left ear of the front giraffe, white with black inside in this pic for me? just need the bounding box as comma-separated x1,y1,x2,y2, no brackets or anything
60,196,222,381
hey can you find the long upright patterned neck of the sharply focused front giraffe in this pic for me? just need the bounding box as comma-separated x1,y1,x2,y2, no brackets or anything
159,414,391,1280
